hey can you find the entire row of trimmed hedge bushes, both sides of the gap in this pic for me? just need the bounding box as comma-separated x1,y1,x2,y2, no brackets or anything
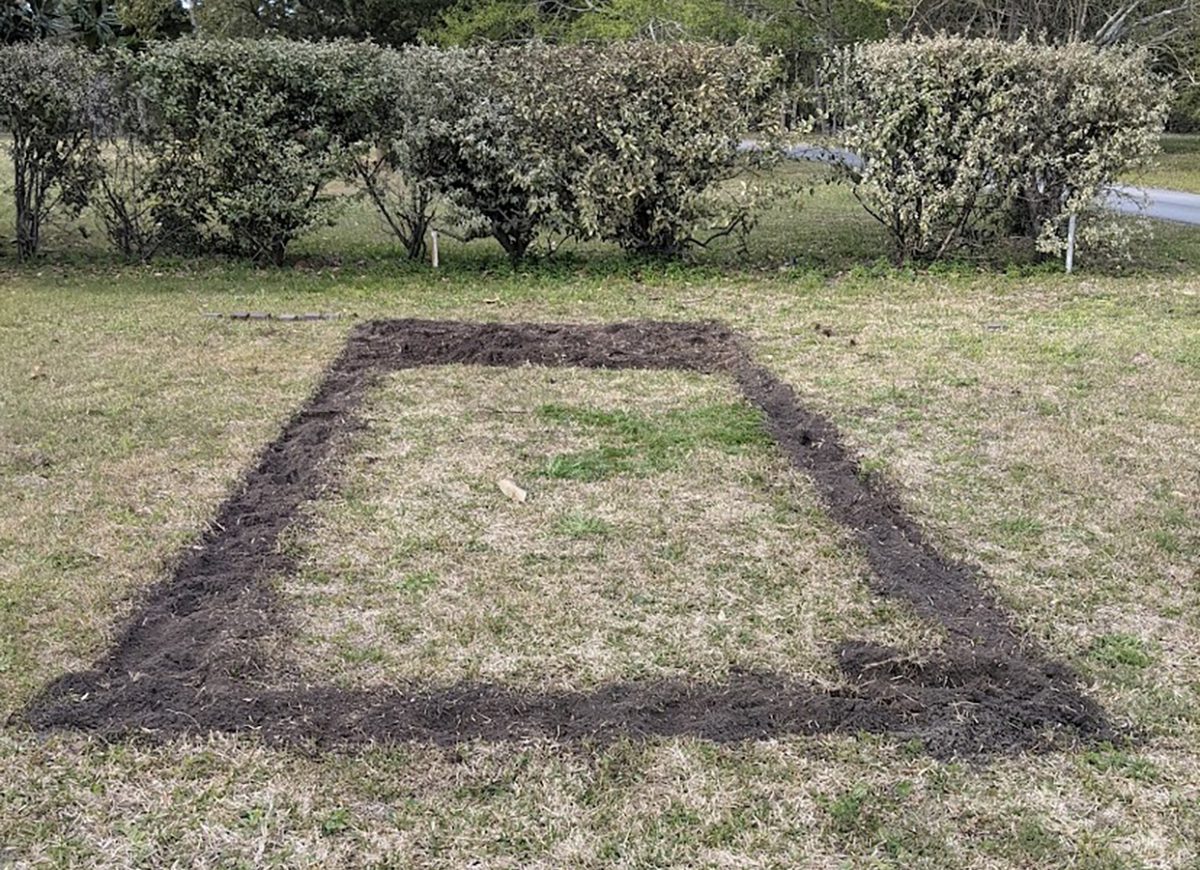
0,37,1168,263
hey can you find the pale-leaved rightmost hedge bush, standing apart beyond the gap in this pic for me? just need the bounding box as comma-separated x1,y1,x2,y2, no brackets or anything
824,36,1169,262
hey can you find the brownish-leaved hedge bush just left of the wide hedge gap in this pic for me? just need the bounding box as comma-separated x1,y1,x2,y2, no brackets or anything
532,42,782,254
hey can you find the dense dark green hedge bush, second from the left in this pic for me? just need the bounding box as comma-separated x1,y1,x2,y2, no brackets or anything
127,40,385,263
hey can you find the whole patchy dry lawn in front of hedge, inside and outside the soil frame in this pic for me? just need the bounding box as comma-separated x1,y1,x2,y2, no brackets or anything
0,159,1200,869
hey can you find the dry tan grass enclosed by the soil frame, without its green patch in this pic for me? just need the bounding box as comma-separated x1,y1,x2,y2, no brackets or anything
276,367,937,691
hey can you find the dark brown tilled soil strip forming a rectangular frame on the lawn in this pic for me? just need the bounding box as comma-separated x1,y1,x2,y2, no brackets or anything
24,320,1114,757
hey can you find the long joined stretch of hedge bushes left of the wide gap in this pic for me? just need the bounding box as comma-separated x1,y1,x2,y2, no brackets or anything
0,40,780,263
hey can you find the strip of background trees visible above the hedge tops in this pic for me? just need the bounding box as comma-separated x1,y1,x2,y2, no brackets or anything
0,0,1200,130
